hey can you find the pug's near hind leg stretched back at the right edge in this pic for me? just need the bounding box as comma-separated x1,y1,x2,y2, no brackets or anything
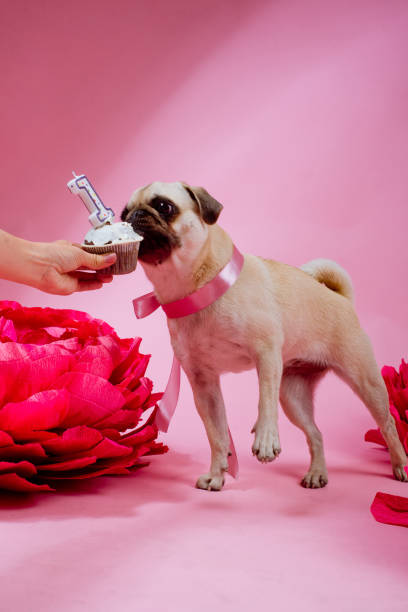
333,329,408,482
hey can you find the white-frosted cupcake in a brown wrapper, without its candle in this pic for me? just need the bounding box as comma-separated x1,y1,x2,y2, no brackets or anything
81,221,143,274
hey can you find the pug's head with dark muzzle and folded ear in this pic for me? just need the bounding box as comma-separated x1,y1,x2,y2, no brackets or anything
121,182,222,264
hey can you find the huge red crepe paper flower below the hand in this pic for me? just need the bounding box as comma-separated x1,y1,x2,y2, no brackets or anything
0,301,168,492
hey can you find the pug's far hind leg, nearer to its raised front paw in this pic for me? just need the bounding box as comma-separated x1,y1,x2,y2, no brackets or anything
280,371,328,489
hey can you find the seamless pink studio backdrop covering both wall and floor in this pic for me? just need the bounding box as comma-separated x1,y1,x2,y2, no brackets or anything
0,0,408,612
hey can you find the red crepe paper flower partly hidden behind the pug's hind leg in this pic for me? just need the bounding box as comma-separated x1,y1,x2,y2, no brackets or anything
364,360,408,453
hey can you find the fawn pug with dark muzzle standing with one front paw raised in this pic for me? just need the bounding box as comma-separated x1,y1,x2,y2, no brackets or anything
121,182,408,491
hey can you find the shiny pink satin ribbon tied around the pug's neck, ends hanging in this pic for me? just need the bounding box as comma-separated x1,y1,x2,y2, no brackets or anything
133,245,244,478
